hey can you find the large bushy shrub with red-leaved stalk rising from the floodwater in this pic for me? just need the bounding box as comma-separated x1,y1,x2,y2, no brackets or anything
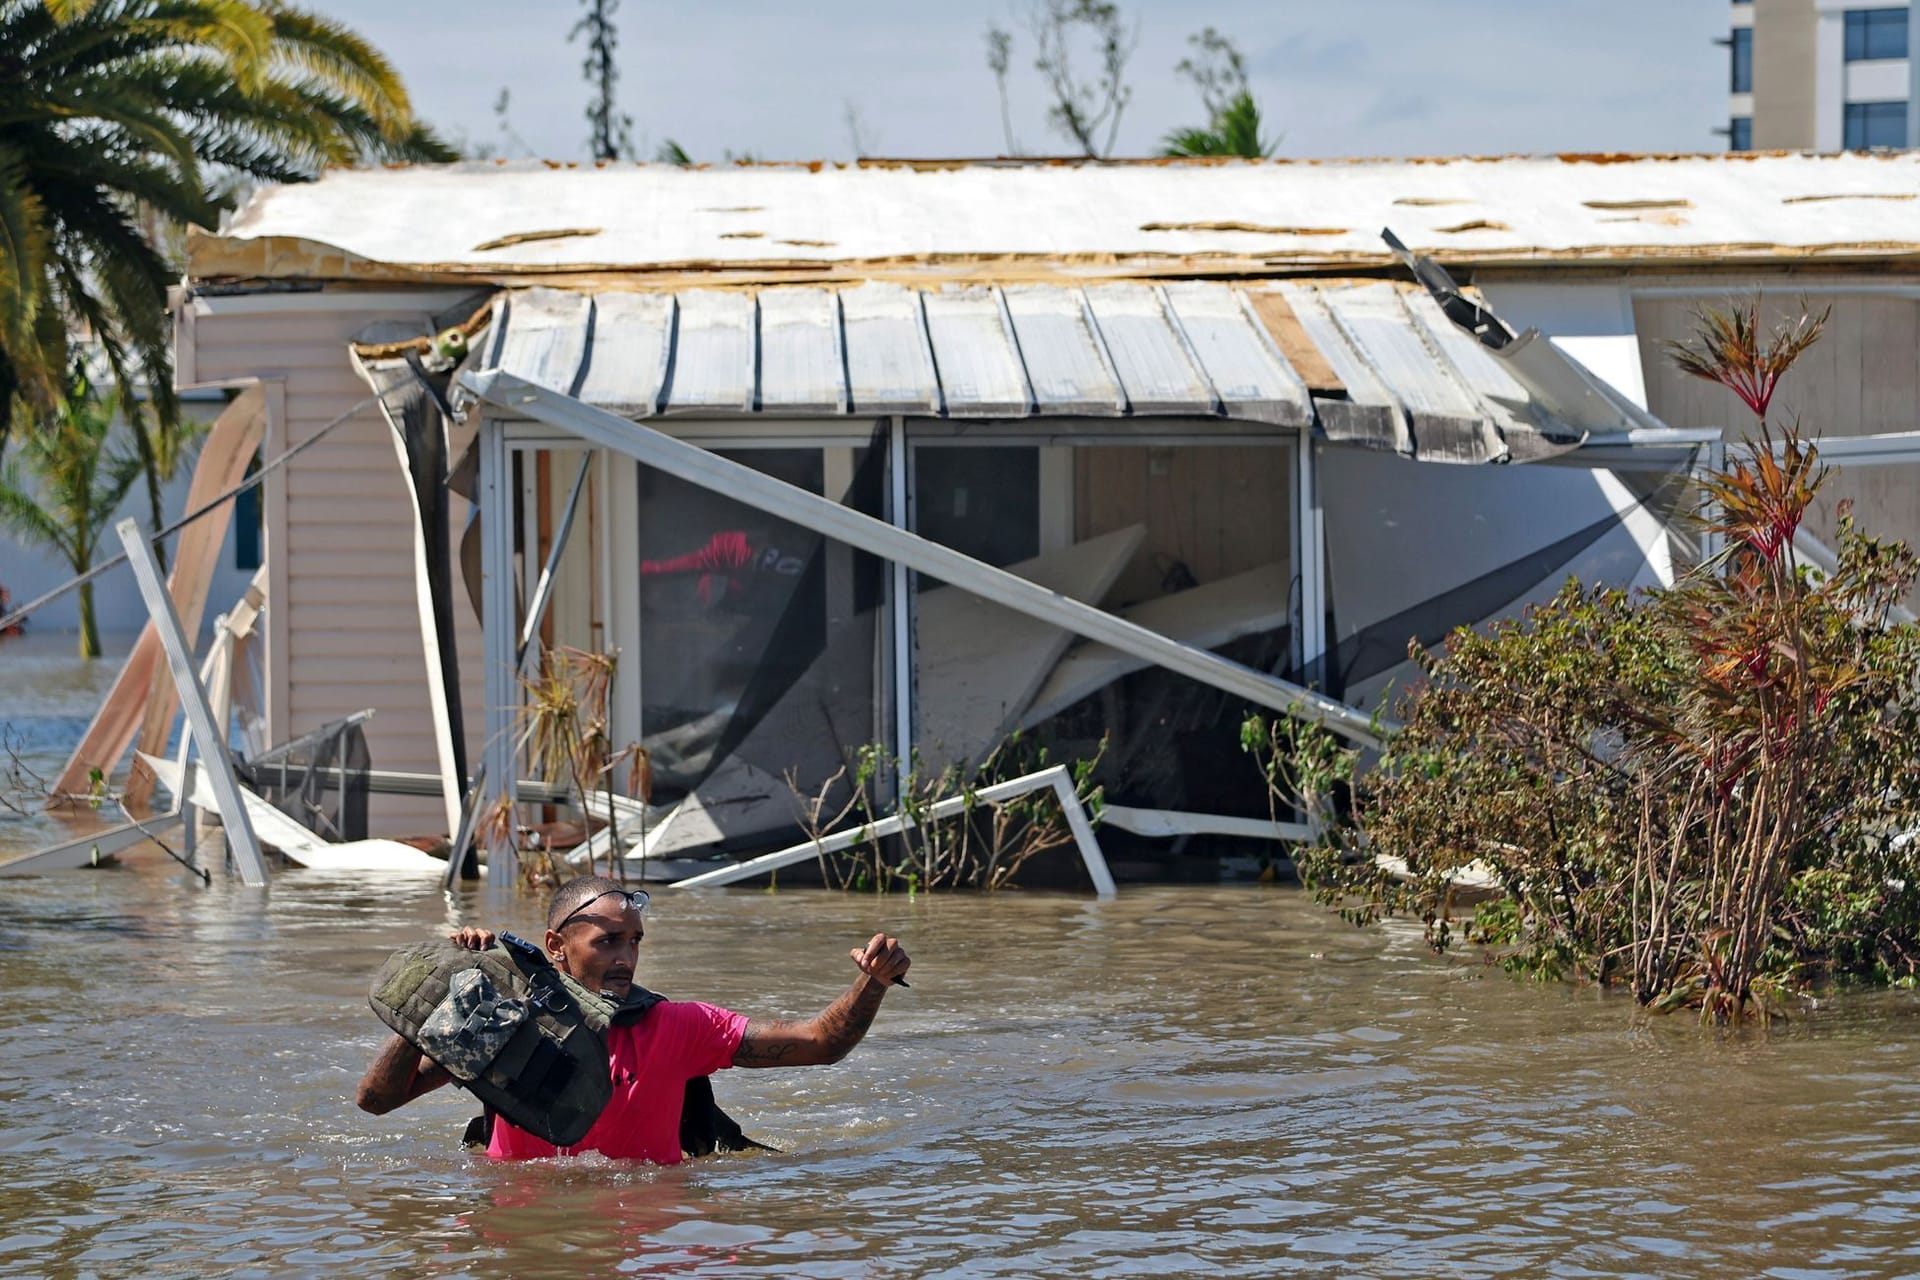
1252,301,1920,1021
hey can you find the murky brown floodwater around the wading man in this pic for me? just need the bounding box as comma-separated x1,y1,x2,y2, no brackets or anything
0,649,1920,1278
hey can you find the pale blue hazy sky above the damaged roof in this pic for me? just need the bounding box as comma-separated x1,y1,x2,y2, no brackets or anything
311,0,1726,159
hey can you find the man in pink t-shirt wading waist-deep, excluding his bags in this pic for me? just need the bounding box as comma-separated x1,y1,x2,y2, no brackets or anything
357,875,910,1165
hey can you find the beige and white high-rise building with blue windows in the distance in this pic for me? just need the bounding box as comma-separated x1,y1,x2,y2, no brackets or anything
1726,0,1920,152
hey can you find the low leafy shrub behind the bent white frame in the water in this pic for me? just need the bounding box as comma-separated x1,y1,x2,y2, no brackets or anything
787,733,1106,892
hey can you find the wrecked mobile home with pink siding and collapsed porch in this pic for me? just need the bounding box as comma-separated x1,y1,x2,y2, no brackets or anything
74,155,1920,886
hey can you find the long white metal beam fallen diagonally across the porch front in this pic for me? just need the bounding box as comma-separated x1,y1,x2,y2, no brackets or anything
459,370,1380,747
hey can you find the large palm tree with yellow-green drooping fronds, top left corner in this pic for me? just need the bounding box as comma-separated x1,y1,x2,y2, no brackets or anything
0,0,453,545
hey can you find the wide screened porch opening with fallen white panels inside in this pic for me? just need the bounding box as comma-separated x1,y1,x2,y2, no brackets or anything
914,441,1294,816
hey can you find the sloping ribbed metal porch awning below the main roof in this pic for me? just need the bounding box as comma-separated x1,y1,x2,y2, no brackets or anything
480,280,1580,462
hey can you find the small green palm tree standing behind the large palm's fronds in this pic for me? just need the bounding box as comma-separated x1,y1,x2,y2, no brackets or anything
0,374,140,658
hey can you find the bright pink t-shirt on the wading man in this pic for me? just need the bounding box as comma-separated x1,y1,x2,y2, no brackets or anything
486,1000,747,1165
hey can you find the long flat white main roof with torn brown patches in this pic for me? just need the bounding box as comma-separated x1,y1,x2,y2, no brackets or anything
190,154,1920,286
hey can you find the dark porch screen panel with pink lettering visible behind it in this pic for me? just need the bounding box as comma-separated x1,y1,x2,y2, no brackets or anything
636,447,885,832
